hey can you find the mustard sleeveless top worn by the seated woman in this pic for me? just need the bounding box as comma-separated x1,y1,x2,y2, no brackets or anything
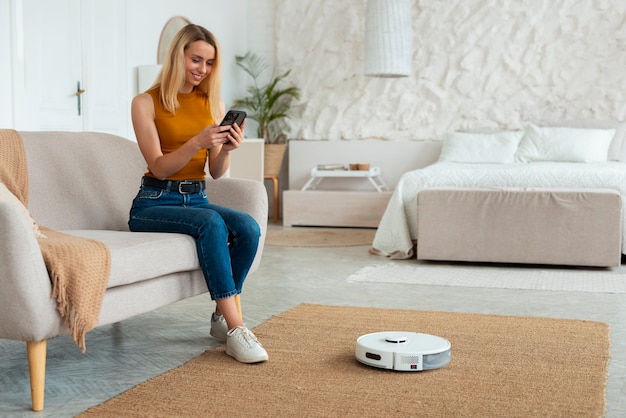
145,88,213,180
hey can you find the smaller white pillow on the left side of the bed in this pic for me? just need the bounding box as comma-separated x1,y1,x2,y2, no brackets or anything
439,131,524,163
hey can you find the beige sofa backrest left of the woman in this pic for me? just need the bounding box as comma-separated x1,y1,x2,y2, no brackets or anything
20,131,146,231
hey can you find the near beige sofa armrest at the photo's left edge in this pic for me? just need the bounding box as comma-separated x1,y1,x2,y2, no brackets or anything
0,202,63,341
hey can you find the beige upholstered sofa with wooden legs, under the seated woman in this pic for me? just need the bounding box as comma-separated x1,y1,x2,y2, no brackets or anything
0,132,268,410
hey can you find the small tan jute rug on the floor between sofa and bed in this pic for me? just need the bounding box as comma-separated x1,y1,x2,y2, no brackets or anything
265,227,376,247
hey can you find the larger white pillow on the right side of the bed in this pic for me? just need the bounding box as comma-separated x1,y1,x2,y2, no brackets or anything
515,123,615,163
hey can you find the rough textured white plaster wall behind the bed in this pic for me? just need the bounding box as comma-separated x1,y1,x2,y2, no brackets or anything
275,0,626,140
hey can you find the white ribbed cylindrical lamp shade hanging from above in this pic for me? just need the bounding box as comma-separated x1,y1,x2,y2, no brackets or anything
365,0,413,77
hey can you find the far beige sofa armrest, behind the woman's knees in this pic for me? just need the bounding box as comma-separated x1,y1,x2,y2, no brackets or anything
206,177,268,272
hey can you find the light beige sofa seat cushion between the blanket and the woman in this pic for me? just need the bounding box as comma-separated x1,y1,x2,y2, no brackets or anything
62,230,200,288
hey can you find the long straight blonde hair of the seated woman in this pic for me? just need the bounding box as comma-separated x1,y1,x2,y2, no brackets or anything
150,24,223,122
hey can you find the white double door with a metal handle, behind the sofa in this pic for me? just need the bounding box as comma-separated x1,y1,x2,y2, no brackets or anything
14,0,127,136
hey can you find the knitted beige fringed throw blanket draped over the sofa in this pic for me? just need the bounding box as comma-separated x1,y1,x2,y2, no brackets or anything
0,130,111,352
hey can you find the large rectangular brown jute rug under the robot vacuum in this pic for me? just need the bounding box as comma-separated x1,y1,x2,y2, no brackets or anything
80,305,609,417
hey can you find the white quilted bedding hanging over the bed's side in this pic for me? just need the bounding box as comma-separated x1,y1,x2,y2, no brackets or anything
372,161,626,258
